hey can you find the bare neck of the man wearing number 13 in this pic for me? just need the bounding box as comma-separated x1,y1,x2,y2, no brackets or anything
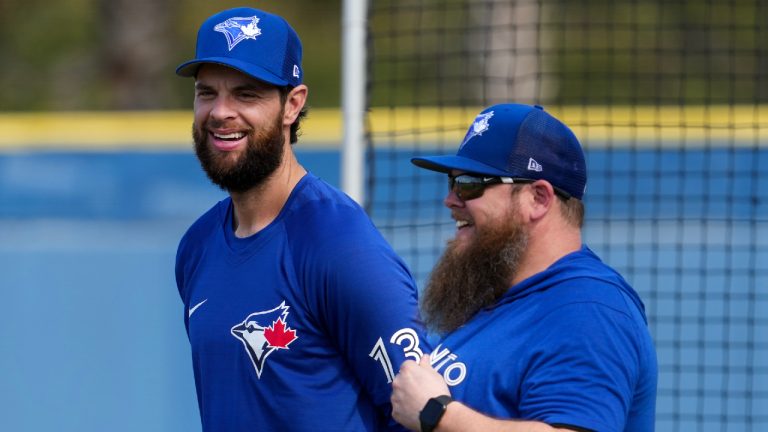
230,141,307,238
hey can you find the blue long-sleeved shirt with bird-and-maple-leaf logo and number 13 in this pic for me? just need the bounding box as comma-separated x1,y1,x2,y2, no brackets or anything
176,174,429,432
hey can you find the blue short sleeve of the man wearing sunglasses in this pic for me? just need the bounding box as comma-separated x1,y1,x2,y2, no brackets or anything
520,302,642,430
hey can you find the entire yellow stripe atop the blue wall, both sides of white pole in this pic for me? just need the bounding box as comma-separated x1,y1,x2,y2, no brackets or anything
0,105,768,150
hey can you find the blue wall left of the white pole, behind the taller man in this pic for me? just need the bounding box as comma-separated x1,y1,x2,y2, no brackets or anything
0,150,339,432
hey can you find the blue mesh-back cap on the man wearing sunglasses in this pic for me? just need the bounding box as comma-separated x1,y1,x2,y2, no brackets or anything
411,104,587,199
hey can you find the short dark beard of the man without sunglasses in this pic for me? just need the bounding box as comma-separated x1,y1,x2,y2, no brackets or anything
192,113,285,192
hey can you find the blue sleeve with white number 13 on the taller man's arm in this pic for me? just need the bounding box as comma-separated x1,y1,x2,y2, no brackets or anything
296,205,430,431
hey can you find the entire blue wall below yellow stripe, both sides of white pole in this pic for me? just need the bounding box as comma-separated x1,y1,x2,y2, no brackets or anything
0,146,768,432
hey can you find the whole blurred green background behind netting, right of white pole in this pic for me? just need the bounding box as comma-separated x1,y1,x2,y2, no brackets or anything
371,0,768,106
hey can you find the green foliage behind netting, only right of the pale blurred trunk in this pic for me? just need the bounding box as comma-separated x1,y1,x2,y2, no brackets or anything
545,0,768,104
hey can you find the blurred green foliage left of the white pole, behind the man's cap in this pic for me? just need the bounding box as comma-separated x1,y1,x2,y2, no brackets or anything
0,0,341,111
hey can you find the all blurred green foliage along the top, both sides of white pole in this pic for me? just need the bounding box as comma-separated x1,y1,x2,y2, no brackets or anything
0,0,768,111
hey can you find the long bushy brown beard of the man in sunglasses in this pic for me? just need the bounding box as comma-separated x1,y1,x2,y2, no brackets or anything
421,212,528,334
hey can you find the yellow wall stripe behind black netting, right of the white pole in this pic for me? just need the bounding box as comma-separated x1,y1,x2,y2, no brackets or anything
364,105,768,147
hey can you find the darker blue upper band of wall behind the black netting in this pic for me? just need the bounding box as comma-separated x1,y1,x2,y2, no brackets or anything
369,147,768,220
